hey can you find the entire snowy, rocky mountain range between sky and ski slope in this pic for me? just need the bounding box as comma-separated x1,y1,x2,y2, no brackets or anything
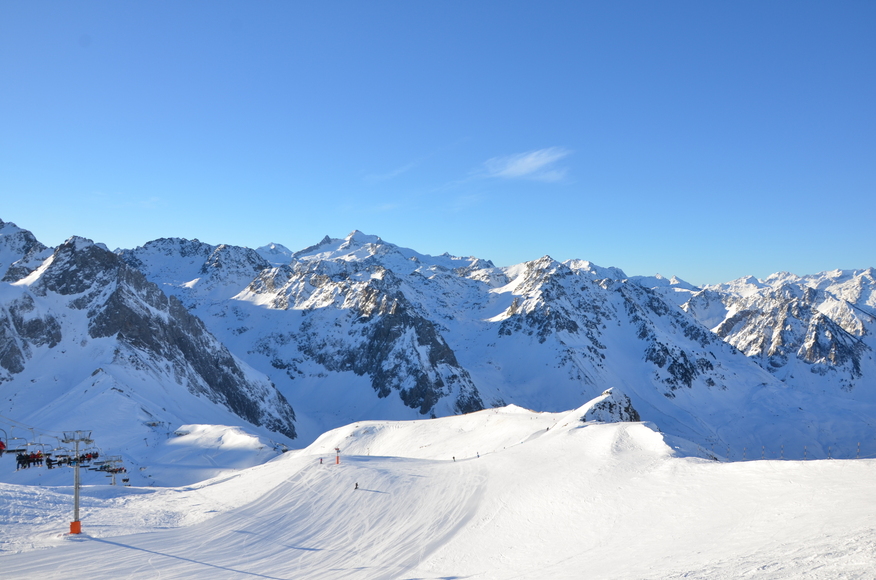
0,215,876,468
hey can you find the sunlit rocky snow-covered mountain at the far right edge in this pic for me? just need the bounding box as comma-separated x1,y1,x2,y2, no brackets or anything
683,268,876,396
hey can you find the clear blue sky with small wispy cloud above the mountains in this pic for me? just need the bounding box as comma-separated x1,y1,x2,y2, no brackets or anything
0,1,876,284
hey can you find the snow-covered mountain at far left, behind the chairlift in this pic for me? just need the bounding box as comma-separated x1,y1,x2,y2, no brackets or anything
0,224,296,484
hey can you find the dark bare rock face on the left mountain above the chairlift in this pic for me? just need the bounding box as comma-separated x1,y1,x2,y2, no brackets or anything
0,238,295,438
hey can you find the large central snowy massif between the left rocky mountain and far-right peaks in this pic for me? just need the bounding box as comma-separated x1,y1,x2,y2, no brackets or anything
121,231,876,455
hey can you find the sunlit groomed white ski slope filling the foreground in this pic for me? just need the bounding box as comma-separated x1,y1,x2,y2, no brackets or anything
0,407,876,580
